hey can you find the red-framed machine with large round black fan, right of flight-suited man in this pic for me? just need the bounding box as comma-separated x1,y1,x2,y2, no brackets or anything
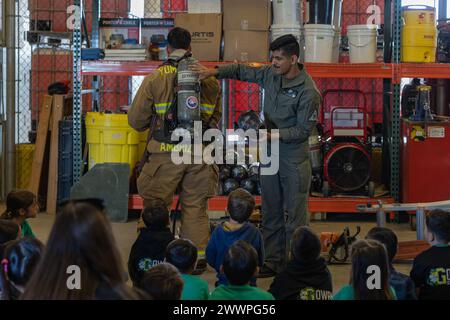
321,89,375,197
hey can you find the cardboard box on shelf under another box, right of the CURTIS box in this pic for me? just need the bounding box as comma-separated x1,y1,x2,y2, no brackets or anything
223,30,269,62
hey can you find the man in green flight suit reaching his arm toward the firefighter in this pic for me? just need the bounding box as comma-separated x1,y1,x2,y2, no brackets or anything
193,35,321,277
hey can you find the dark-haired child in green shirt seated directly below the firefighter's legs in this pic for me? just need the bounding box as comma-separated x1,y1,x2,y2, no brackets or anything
165,239,209,300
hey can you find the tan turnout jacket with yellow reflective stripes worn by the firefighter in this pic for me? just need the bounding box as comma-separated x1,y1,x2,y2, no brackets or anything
128,49,222,153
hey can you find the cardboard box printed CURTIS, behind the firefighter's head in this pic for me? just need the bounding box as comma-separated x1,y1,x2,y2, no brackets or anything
175,13,222,61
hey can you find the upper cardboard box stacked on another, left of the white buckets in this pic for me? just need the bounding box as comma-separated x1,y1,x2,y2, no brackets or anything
223,0,272,31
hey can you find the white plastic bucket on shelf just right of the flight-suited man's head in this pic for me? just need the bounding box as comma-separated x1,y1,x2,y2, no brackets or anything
305,24,336,63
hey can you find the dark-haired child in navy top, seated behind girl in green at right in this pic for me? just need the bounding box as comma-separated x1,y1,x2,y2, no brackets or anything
366,227,417,300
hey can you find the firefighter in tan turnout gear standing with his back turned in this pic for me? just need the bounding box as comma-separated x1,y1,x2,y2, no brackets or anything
128,28,221,271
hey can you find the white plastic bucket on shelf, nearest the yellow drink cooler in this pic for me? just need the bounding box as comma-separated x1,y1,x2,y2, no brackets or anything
347,24,377,63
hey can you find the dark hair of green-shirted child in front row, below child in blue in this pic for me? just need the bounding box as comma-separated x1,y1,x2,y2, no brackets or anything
223,240,258,285
